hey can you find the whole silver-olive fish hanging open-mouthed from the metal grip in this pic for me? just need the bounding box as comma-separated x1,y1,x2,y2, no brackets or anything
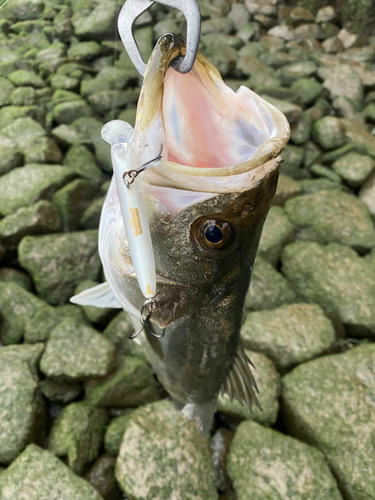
73,34,290,435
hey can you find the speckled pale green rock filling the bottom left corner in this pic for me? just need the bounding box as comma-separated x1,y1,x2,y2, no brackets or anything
0,445,103,500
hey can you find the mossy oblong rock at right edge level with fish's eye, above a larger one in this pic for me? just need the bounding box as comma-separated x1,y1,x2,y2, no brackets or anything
285,190,375,251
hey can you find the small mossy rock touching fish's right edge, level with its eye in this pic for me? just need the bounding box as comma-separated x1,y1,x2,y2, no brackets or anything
258,207,294,266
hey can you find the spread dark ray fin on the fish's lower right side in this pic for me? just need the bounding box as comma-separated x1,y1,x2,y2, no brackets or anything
221,343,262,412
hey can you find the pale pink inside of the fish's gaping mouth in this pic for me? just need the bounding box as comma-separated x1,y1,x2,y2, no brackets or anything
163,67,272,168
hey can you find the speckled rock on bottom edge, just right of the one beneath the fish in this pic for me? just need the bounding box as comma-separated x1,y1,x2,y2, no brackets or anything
227,421,341,500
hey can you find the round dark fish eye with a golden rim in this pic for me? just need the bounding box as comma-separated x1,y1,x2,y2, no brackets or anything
193,219,233,250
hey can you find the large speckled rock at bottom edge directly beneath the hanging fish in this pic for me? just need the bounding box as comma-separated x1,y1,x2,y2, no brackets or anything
116,401,218,500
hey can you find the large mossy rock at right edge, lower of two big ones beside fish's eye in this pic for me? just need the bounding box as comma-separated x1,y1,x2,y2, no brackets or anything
281,241,375,338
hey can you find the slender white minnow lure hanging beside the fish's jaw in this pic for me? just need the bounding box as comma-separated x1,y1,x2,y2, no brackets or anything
102,120,156,299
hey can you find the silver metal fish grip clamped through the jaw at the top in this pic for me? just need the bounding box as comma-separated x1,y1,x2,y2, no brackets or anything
118,0,201,76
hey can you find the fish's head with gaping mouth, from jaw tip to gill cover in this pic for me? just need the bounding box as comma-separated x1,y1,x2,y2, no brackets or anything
99,34,290,327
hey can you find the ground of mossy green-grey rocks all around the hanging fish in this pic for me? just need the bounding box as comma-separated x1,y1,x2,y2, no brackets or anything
0,0,375,500
